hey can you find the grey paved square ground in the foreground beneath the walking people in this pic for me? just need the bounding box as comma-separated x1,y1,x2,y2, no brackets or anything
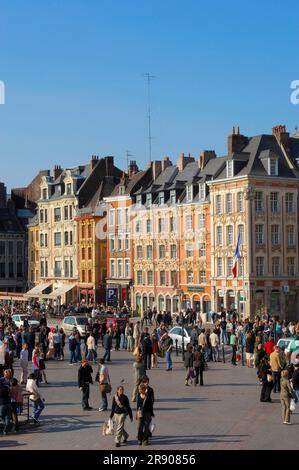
0,340,299,450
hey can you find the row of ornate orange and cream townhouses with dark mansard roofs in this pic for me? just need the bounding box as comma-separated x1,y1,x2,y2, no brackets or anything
0,126,299,320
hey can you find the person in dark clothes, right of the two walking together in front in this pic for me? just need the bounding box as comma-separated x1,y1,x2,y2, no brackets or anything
136,383,154,446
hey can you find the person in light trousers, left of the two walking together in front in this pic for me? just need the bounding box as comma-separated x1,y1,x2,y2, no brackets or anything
110,385,133,447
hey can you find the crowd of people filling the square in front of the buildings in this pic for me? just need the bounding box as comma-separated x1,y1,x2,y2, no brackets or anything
0,305,299,447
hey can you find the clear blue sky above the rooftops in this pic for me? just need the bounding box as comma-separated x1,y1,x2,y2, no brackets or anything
0,0,299,187
